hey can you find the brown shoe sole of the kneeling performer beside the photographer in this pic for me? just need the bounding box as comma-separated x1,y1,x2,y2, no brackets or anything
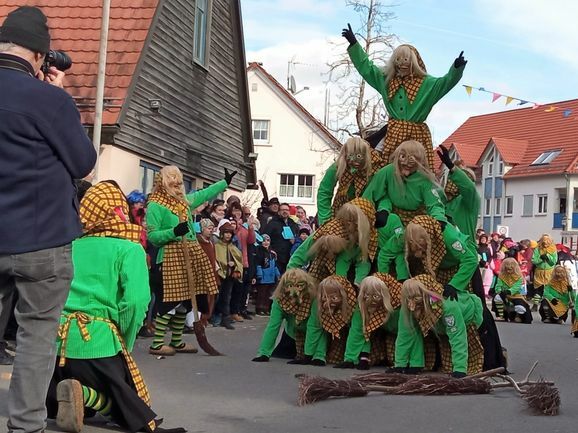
56,379,84,433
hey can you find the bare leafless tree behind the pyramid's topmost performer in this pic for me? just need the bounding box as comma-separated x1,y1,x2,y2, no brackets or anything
328,0,398,138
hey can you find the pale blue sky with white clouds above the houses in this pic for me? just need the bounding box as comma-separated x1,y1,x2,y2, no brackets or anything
241,0,578,145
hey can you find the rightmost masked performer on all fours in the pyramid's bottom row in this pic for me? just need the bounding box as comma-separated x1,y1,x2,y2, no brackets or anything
395,276,482,378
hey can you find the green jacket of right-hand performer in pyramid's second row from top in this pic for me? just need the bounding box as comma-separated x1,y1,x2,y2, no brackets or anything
446,167,481,244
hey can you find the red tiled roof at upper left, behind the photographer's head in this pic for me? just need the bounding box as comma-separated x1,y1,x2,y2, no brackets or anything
0,0,159,125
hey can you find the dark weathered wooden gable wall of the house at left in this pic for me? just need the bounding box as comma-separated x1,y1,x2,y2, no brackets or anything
114,0,255,189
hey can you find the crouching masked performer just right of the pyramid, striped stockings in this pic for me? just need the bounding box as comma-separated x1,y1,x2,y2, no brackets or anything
493,257,532,323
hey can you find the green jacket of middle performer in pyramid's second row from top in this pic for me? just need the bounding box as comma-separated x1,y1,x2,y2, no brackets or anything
363,164,446,221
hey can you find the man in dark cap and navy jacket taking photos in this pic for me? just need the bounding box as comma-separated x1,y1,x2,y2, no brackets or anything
0,6,96,433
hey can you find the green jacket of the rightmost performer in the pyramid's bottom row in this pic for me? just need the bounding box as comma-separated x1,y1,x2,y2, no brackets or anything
395,294,482,373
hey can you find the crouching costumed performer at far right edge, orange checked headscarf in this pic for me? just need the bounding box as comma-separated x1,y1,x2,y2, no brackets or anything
538,265,573,323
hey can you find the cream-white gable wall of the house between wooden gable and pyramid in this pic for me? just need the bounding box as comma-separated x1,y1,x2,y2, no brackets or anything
248,71,335,215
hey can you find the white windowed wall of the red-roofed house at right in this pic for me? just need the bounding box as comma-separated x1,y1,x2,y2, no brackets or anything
502,175,566,242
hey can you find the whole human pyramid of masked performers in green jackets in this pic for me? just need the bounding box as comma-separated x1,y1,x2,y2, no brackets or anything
253,25,505,377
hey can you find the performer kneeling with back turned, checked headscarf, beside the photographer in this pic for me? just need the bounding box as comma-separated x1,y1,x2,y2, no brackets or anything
46,181,186,433
